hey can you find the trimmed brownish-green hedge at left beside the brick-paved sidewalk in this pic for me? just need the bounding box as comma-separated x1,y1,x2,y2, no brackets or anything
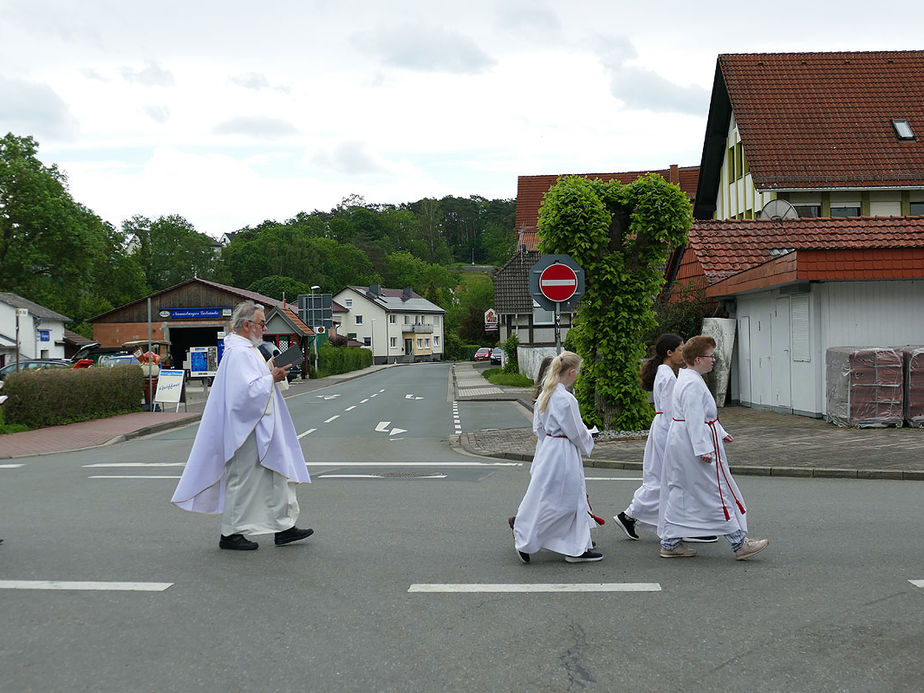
3,365,145,428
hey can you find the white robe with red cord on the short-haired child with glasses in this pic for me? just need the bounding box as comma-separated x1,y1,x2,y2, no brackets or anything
658,368,748,539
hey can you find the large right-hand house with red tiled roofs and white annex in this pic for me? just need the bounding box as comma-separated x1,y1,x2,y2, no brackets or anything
666,51,924,417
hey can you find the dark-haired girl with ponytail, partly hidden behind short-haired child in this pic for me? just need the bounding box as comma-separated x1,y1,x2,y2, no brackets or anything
613,334,683,540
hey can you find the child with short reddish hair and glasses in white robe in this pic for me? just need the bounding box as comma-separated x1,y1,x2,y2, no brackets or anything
658,336,770,560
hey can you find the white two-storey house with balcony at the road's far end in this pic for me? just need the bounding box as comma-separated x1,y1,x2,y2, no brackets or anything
333,284,446,363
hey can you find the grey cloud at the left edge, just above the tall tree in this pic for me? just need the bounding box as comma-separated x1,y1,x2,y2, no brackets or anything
0,76,77,140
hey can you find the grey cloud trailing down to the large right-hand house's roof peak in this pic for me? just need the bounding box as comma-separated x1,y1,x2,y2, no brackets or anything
598,36,709,115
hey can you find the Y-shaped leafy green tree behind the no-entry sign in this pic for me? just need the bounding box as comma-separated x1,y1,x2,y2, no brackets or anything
539,174,692,431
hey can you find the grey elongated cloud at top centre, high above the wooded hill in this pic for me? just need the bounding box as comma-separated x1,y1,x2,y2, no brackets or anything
353,25,495,74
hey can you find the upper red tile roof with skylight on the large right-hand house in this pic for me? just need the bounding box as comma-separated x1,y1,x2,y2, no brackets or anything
714,51,924,190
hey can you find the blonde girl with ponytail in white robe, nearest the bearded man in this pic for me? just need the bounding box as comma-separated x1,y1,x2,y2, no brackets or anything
513,351,603,563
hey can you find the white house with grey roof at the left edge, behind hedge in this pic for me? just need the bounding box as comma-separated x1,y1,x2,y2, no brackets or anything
0,292,71,366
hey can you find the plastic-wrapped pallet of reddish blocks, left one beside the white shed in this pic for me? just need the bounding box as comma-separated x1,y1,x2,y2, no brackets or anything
825,346,904,428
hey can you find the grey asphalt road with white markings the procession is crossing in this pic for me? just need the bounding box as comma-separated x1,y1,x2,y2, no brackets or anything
0,364,924,692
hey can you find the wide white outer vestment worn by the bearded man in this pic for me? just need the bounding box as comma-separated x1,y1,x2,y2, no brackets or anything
172,333,311,514
